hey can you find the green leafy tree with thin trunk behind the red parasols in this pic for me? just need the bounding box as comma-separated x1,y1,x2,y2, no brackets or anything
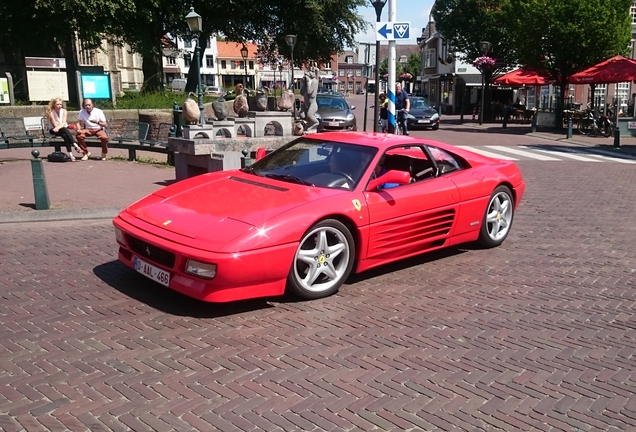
507,0,633,121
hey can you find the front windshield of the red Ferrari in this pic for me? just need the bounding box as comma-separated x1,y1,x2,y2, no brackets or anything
244,137,377,190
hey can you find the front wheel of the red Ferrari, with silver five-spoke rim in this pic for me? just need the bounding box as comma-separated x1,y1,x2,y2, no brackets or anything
287,219,355,300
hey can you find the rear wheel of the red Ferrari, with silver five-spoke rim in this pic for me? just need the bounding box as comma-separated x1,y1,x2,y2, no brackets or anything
478,186,514,248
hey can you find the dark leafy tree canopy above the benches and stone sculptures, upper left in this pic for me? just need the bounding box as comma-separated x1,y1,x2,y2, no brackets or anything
0,0,368,94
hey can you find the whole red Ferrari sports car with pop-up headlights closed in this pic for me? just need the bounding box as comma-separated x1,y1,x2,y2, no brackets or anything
113,132,524,302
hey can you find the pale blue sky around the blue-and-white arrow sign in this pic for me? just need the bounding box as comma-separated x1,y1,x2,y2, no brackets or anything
356,0,435,44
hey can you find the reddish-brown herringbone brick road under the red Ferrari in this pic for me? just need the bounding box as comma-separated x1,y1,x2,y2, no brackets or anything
0,160,636,432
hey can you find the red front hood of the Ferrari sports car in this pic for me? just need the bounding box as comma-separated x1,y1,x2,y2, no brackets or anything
127,171,342,240
